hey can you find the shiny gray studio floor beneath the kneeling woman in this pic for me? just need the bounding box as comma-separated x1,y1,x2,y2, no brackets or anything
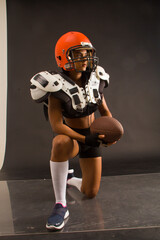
0,173,160,240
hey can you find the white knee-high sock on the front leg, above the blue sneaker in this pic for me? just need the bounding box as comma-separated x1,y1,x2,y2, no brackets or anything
50,161,68,206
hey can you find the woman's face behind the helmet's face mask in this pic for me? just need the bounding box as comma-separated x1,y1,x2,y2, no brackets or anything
73,49,88,72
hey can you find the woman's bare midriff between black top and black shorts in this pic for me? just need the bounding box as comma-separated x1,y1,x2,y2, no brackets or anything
64,113,95,129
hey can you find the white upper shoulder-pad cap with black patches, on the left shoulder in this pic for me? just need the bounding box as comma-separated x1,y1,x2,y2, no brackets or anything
30,71,63,92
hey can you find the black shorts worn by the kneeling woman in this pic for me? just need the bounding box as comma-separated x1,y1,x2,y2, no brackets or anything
72,128,101,158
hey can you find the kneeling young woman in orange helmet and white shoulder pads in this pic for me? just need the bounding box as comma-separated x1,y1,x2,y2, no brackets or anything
31,32,112,230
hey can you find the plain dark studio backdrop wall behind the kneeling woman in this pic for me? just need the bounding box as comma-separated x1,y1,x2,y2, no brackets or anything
0,0,160,179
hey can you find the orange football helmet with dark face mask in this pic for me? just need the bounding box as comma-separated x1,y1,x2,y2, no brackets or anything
55,32,98,72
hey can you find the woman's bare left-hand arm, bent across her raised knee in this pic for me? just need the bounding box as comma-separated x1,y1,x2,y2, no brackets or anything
48,95,85,143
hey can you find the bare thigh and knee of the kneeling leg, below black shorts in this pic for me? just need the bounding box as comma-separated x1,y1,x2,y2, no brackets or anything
79,157,102,198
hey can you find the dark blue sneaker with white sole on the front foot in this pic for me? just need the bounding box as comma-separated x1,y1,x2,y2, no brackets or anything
46,203,69,231
